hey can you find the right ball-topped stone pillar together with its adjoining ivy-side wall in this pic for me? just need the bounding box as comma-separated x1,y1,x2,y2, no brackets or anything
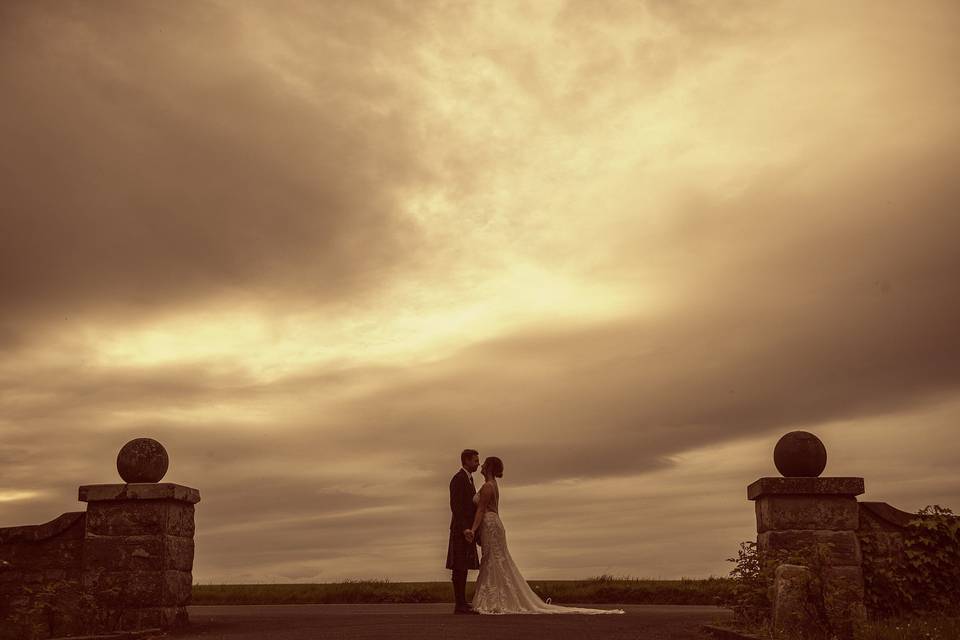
747,431,949,640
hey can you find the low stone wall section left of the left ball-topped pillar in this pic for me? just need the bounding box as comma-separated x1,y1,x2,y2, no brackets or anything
0,511,87,640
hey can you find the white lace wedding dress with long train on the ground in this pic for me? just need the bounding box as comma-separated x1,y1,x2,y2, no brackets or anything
471,483,623,614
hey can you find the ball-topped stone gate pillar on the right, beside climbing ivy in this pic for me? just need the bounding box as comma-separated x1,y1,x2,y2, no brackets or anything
747,432,866,638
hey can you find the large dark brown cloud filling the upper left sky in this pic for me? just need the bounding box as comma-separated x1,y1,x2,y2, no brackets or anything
0,3,428,340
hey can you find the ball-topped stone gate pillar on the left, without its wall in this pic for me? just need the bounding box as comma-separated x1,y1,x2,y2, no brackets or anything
79,438,200,633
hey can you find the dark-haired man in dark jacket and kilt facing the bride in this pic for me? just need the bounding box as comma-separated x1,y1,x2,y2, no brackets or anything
447,449,480,613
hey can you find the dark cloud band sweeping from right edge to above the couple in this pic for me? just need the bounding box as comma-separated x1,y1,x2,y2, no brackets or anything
310,145,960,482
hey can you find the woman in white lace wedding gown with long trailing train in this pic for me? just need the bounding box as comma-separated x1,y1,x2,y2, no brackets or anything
465,456,623,613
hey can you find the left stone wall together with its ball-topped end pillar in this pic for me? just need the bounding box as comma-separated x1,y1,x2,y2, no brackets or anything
0,438,200,640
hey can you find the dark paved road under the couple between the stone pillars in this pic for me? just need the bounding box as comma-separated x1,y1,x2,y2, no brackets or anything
167,604,730,640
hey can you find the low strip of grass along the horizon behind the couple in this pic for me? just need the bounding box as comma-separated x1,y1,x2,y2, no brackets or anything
191,576,733,605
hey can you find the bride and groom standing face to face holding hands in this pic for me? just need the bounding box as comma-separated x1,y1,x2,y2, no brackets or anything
447,449,623,614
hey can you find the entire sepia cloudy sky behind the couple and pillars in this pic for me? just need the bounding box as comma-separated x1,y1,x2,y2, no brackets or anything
0,0,960,583
